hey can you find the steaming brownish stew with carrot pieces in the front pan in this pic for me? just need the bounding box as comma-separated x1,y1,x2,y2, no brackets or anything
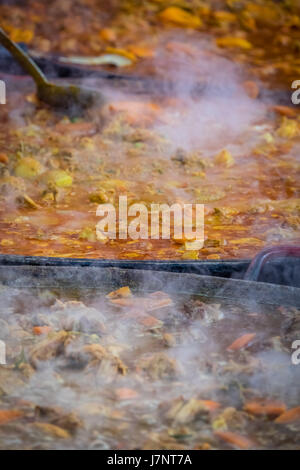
0,280,300,450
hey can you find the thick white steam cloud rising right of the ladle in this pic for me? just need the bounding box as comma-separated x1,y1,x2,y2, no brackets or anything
152,39,266,151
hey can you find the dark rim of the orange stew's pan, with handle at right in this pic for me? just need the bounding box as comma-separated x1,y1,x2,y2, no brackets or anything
0,246,300,287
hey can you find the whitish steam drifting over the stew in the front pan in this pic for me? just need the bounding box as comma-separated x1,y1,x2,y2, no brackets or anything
0,268,299,449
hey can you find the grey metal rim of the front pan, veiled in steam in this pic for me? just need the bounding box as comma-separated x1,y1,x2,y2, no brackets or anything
0,258,300,307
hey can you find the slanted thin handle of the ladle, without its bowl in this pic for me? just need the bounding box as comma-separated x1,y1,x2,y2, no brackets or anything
0,28,49,86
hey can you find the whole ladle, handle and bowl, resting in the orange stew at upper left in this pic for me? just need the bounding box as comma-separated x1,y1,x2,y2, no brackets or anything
0,28,105,116
